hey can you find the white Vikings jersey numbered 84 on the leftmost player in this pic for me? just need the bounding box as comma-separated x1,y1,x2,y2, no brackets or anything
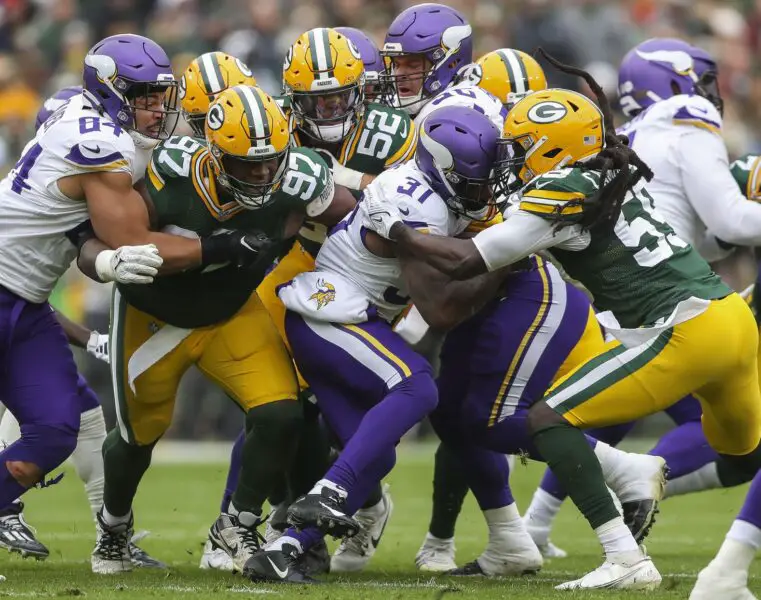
0,95,145,302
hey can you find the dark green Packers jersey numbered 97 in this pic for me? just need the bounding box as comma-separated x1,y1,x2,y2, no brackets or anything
119,136,333,328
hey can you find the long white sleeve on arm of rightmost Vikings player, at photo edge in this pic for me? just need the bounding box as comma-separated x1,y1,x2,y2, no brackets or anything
676,128,761,246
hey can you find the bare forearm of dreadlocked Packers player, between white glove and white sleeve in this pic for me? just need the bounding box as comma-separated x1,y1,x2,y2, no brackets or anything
390,223,487,280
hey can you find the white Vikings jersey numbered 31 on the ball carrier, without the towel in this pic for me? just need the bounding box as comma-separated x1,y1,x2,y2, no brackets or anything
316,161,471,321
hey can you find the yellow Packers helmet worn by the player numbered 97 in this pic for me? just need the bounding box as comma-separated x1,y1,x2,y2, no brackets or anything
205,85,291,210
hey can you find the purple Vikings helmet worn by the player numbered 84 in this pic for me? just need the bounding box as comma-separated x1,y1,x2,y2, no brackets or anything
83,34,180,146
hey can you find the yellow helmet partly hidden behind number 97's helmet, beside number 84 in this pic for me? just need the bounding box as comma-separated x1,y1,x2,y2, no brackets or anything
180,52,256,137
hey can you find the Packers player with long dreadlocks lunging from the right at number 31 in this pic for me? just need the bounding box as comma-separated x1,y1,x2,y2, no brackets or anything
365,59,761,589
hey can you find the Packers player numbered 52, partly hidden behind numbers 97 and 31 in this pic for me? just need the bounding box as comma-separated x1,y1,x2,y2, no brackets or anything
252,28,417,571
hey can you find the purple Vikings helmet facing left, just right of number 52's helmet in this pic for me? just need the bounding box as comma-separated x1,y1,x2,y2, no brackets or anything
381,3,473,115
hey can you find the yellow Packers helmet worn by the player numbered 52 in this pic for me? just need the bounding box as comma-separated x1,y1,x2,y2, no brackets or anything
283,27,365,142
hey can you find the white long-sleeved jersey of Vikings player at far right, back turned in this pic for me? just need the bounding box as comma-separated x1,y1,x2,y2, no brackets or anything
618,95,761,261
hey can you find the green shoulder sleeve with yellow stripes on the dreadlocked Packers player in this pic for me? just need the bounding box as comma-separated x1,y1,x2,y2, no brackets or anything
519,168,600,220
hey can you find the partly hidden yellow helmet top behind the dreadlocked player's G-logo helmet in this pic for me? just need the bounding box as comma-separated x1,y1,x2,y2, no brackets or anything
463,48,547,110
